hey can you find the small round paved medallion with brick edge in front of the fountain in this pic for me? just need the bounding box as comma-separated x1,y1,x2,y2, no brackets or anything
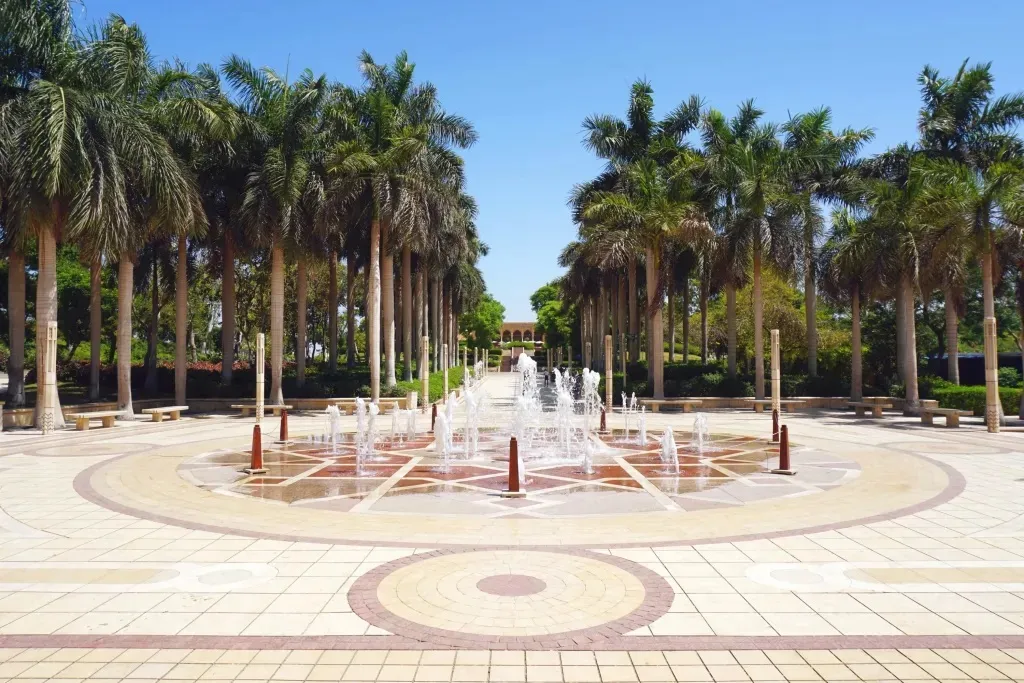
349,549,673,647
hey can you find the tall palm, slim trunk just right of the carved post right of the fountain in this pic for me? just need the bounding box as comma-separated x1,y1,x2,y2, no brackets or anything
781,106,873,377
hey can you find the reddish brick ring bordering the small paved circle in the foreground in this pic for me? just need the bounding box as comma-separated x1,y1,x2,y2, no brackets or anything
348,548,673,649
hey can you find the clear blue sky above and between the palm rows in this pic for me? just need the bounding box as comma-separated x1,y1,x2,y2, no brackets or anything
77,0,1024,319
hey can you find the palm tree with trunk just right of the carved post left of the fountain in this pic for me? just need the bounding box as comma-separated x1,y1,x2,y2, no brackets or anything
223,56,329,404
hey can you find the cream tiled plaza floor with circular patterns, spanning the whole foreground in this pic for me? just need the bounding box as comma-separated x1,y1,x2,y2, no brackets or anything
0,374,1024,683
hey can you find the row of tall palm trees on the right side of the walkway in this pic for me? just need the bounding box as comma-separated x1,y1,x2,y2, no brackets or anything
561,61,1024,421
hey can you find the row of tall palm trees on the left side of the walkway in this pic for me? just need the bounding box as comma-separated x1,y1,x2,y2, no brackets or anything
0,0,486,428
